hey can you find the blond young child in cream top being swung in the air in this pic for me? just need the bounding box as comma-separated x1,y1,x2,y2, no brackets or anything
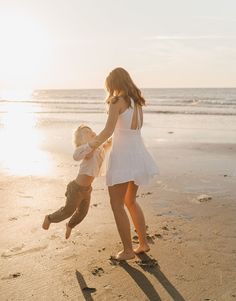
42,125,111,239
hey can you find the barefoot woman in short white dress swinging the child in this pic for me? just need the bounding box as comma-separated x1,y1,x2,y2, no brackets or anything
89,68,157,260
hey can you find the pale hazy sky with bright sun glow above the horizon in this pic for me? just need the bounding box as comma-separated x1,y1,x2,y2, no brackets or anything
0,0,236,89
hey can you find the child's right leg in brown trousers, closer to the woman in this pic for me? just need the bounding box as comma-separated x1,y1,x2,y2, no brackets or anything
66,191,91,238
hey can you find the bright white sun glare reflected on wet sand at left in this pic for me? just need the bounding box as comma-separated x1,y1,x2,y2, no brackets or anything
0,102,52,176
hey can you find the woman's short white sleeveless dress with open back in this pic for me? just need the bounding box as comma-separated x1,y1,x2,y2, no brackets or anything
106,100,158,186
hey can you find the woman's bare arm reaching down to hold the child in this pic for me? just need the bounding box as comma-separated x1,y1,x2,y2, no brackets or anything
89,101,121,149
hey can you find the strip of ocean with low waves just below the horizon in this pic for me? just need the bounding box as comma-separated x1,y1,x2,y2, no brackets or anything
0,88,236,117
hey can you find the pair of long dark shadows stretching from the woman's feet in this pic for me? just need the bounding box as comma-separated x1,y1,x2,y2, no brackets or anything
120,254,185,301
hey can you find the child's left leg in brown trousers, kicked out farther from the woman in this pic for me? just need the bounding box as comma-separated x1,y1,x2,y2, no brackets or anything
42,181,79,229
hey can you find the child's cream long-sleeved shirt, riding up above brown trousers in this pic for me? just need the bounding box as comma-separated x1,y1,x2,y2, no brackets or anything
73,143,105,177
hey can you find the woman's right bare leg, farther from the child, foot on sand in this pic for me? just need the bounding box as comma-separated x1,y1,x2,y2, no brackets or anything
125,182,150,253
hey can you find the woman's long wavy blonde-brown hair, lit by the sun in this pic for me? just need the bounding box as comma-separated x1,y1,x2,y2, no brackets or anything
105,67,145,106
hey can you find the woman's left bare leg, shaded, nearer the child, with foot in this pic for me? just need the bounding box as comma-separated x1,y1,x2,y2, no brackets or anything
108,183,134,260
